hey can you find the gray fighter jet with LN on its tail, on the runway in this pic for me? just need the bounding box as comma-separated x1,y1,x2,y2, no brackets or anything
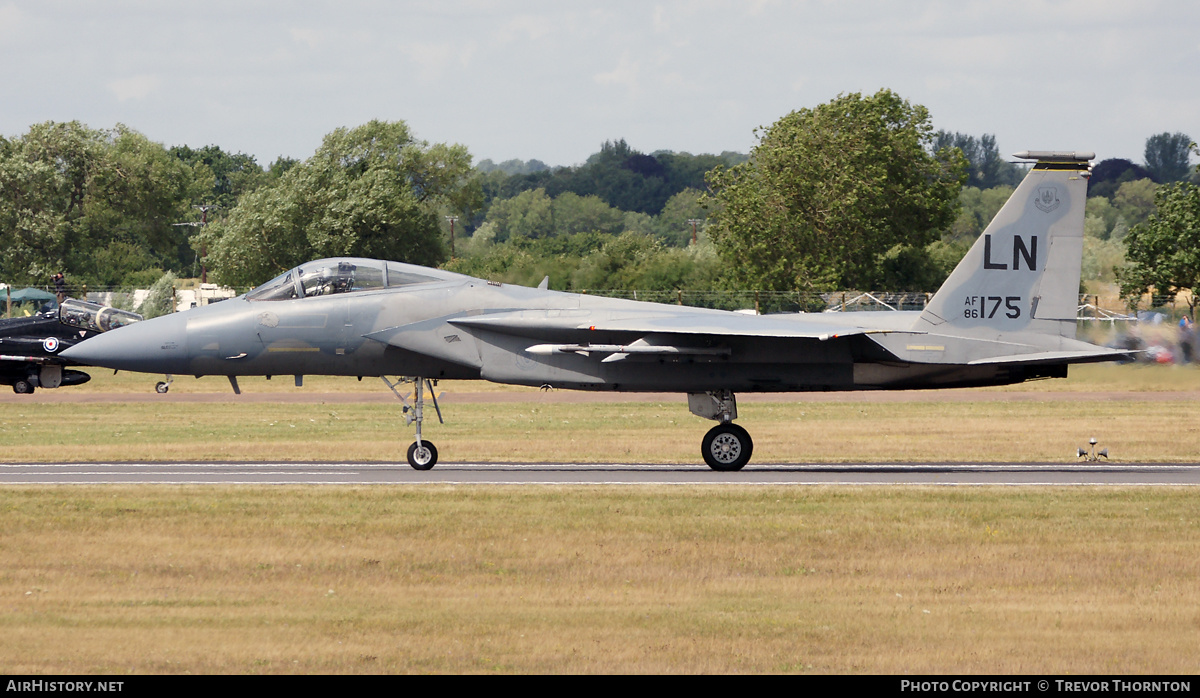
62,152,1126,470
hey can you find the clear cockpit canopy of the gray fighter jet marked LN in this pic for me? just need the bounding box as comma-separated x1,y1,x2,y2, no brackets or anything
246,257,457,301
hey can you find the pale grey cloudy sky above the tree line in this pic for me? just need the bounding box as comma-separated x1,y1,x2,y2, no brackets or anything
0,0,1200,166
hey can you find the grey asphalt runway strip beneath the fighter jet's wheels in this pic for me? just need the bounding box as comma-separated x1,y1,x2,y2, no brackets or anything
0,463,1200,486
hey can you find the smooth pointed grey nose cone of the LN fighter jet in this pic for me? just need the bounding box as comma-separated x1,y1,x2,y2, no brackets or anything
59,313,187,373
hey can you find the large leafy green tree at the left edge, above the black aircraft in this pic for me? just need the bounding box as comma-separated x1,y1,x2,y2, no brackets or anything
0,121,196,287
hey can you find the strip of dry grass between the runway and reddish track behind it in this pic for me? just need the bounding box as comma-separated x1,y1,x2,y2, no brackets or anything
0,393,1200,467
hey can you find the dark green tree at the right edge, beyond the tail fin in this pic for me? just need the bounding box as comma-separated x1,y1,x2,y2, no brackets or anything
1117,182,1200,318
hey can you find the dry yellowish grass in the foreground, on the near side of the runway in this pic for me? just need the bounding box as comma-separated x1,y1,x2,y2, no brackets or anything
0,486,1200,674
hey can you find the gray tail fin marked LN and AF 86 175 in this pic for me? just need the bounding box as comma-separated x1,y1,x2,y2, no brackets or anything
913,151,1096,338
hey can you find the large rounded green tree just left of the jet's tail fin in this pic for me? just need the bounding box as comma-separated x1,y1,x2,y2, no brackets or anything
708,90,966,291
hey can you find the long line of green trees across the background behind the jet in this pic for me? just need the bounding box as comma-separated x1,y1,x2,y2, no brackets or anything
0,95,1200,309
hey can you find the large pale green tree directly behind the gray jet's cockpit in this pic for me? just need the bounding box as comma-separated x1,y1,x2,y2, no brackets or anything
196,121,478,285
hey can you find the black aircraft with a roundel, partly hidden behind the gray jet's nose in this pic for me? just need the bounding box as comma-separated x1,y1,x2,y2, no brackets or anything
0,299,142,393
